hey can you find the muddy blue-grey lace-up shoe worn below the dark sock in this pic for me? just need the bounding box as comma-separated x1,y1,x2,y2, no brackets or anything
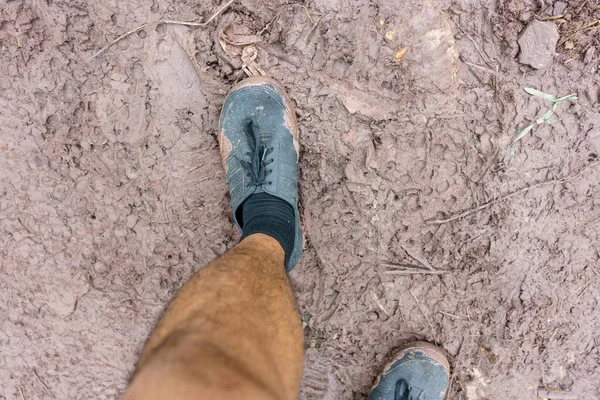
219,76,302,271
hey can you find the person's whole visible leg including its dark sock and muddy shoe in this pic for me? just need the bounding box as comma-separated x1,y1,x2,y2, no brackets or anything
125,77,303,400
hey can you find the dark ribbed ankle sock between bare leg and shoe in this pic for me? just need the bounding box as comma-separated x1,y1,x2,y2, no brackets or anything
238,193,296,266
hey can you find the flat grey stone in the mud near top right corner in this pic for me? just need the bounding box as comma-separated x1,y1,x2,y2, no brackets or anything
518,21,559,69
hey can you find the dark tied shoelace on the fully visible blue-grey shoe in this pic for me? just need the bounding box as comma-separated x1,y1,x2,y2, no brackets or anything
240,121,273,187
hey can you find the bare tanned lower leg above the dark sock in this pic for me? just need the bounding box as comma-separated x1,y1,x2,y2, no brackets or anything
125,234,303,400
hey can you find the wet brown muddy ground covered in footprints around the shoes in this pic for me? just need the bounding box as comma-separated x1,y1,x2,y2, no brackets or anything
0,0,600,400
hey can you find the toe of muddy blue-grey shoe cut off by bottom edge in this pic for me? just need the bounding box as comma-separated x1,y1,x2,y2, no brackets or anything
368,342,450,400
